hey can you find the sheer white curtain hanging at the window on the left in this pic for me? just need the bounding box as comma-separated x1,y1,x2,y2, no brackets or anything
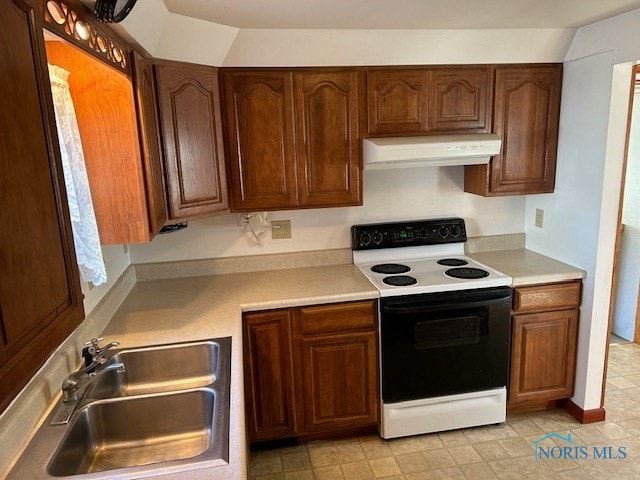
49,65,107,285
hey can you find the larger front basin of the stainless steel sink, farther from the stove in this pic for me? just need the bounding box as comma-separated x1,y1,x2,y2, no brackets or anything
47,389,220,476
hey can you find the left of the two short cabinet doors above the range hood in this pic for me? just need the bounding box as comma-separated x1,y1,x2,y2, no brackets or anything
367,68,429,135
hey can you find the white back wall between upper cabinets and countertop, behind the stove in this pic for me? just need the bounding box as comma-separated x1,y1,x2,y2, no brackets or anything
131,166,525,263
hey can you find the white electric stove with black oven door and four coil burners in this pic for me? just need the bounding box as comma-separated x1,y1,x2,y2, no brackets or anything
351,218,512,438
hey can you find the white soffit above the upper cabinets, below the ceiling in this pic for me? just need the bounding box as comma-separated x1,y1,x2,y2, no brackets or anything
115,0,575,66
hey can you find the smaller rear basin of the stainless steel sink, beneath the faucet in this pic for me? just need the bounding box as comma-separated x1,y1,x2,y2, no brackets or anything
87,341,220,399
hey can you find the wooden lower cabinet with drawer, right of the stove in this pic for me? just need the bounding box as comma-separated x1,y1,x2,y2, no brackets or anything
508,281,581,412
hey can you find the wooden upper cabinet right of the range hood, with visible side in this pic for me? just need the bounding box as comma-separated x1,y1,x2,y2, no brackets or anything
465,64,562,196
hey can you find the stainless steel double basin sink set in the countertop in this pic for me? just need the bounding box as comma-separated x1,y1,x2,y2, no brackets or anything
11,338,231,478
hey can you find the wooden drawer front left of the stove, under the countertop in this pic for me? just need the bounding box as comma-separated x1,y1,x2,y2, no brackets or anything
300,300,376,335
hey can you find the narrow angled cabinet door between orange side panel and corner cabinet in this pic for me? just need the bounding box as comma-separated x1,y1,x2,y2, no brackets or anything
133,50,167,235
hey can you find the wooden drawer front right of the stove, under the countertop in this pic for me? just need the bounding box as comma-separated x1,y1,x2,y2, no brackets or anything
513,282,581,312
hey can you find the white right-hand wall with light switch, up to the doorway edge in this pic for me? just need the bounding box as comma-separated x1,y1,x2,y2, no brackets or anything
525,6,640,410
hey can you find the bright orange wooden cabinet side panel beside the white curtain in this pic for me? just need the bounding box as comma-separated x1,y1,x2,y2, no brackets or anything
47,41,150,245
